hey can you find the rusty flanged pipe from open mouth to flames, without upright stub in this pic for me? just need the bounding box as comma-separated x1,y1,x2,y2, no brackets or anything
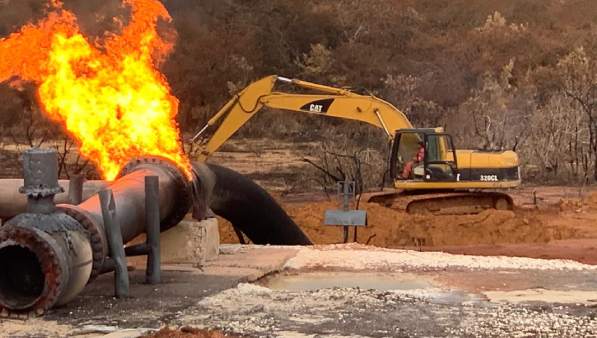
0,157,191,318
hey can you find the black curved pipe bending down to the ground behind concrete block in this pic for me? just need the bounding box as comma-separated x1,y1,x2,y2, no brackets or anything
192,162,312,245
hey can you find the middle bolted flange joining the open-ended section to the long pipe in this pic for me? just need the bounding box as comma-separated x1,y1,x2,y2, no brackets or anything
56,204,108,284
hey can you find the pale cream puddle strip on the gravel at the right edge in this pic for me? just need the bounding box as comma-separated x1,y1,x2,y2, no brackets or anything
483,289,597,305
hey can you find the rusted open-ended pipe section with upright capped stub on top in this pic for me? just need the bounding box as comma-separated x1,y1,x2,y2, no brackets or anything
0,148,92,316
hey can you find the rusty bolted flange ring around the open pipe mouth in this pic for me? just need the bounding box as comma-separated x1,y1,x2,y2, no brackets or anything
0,225,69,318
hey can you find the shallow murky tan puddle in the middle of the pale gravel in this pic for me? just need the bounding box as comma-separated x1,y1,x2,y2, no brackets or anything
266,272,433,291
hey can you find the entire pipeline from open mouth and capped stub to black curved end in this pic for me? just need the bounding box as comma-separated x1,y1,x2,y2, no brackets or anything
0,148,311,318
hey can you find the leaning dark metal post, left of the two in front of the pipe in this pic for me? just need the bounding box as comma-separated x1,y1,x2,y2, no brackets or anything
98,189,130,298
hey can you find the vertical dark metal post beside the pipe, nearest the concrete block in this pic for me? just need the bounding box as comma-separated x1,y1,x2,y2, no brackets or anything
145,176,161,284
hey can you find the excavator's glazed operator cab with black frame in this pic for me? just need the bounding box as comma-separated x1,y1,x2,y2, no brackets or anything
390,129,460,182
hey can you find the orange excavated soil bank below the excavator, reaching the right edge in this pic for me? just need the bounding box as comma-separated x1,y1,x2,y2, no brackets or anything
220,194,597,247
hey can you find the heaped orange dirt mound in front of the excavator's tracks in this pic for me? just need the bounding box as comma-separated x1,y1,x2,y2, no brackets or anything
220,202,576,247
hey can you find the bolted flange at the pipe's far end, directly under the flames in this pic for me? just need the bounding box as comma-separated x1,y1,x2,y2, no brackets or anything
118,156,192,231
